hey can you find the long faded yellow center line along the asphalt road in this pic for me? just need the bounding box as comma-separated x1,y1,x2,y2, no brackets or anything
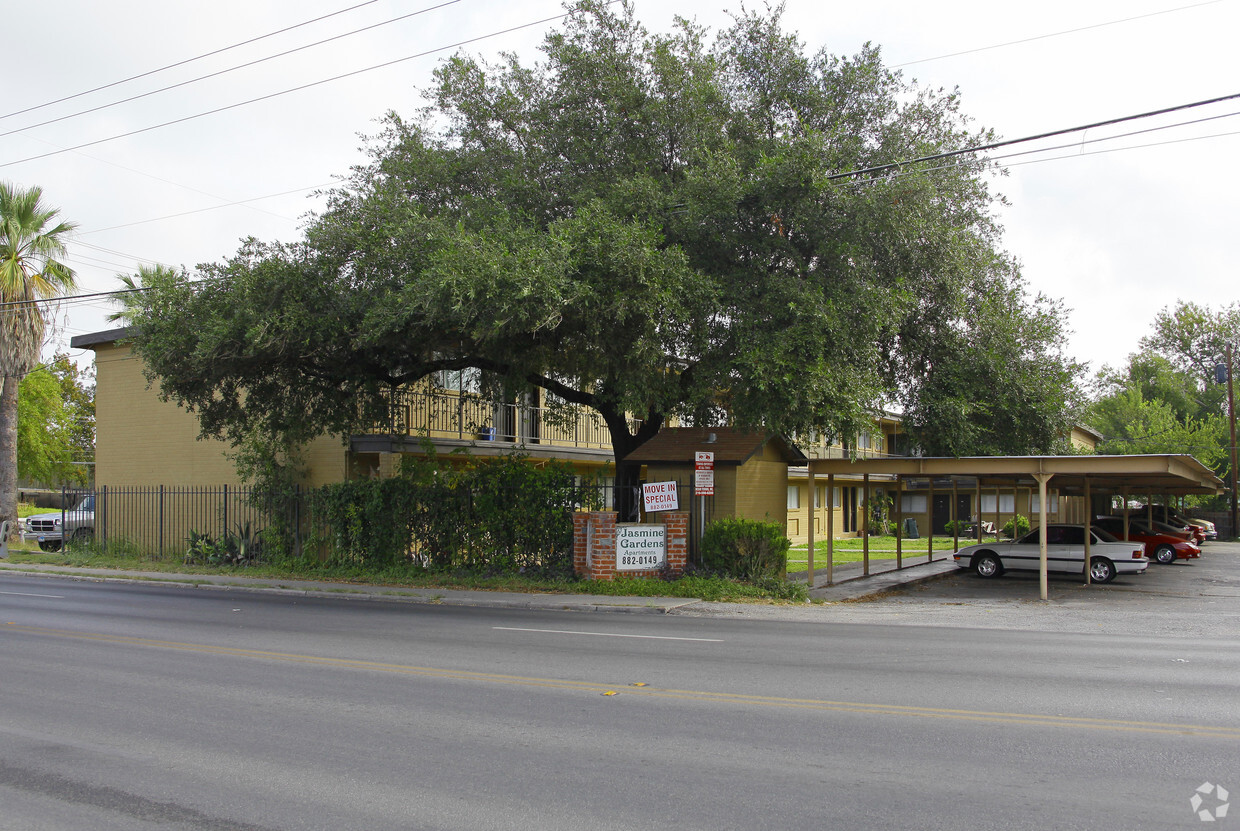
12,623,1240,739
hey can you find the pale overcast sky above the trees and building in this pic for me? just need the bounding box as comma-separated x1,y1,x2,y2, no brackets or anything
0,0,1240,384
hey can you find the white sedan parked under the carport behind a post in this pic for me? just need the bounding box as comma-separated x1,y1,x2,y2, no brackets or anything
955,525,1149,583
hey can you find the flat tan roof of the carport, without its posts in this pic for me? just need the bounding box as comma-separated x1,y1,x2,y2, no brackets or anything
810,454,1225,494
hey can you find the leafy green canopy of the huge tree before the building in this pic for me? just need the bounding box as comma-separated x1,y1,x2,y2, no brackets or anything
118,0,1076,496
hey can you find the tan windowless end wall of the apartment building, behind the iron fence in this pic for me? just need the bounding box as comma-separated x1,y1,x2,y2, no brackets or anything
95,344,346,485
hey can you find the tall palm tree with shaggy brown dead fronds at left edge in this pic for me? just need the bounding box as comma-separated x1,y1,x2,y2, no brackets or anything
0,182,77,540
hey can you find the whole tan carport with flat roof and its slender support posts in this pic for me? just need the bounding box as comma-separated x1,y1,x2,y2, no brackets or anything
807,454,1225,600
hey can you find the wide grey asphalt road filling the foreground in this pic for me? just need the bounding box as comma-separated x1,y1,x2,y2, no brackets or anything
0,561,1240,831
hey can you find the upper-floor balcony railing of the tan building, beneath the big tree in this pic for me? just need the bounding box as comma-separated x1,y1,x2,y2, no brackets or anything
370,389,629,450
